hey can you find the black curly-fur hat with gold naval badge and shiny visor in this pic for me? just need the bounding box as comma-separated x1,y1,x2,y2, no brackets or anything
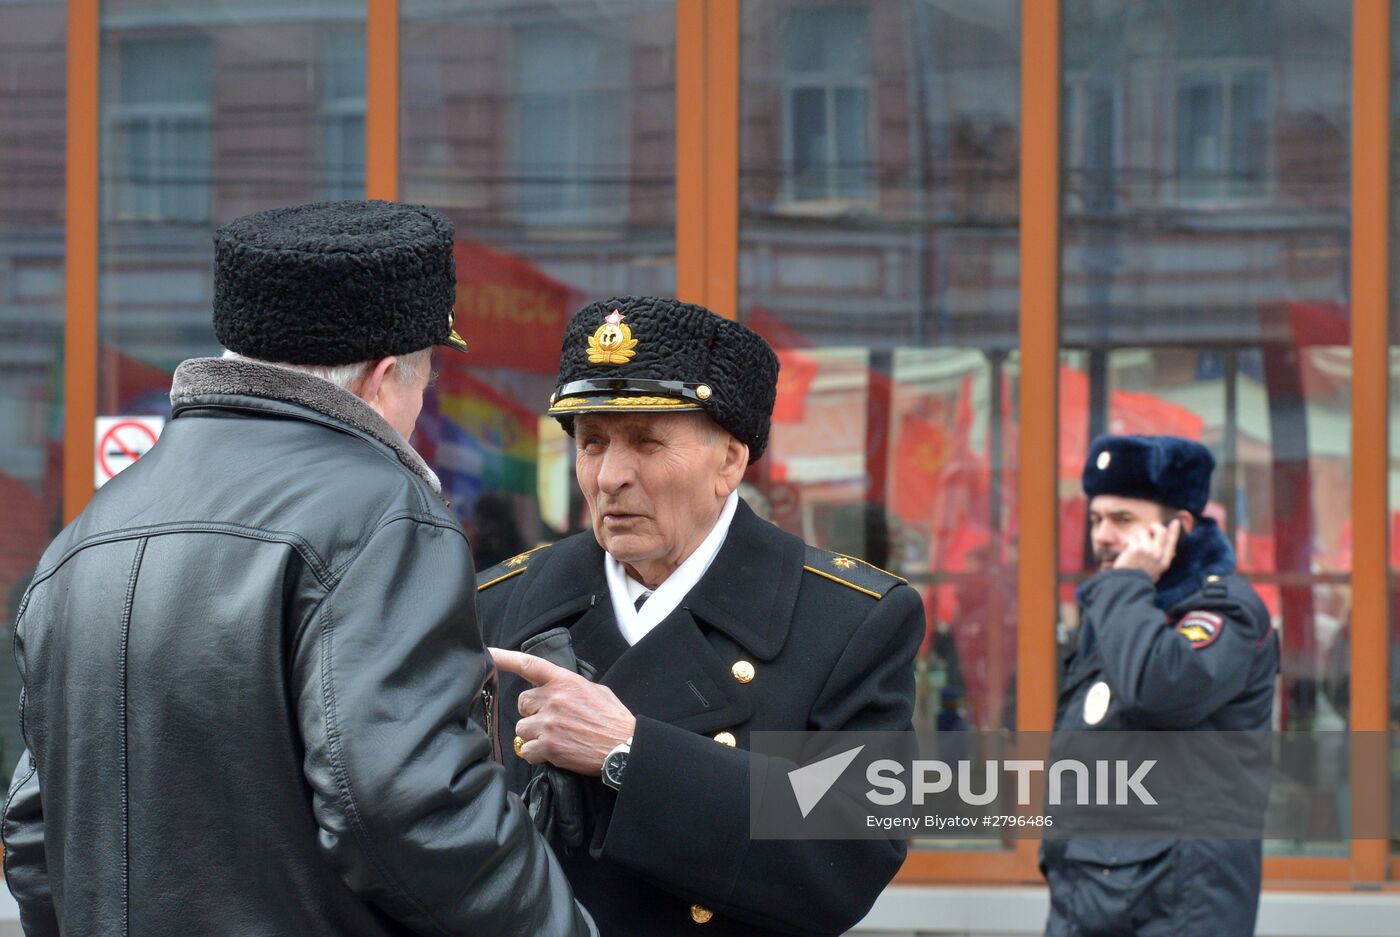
549,297,778,462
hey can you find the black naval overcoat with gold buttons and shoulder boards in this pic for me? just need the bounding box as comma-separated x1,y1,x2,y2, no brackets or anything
477,501,924,937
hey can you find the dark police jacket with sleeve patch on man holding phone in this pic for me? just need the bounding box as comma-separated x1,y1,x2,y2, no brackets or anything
1042,520,1278,937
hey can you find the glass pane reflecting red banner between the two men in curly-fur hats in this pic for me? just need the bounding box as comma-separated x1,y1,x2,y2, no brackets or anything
399,0,676,569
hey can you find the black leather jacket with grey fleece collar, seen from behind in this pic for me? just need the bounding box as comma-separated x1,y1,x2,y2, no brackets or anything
3,359,592,937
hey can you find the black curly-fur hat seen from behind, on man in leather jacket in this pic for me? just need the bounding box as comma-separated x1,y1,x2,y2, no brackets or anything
214,200,466,364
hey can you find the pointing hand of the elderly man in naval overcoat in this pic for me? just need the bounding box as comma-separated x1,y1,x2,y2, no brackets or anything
490,647,637,776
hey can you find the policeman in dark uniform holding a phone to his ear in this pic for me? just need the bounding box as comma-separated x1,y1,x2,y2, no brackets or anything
1040,436,1278,937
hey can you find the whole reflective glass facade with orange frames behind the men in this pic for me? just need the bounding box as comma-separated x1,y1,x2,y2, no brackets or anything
8,0,1400,881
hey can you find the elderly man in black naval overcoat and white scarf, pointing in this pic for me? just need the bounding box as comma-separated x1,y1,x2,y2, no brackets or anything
477,298,924,937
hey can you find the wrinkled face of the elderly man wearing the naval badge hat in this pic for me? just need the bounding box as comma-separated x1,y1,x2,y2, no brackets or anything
574,413,748,583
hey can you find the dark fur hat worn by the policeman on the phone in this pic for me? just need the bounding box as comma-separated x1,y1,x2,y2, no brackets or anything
1084,436,1215,514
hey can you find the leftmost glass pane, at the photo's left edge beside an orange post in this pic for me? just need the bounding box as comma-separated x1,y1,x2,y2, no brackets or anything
0,0,67,777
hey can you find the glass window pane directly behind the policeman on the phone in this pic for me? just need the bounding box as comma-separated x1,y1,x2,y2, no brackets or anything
1060,0,1351,850
